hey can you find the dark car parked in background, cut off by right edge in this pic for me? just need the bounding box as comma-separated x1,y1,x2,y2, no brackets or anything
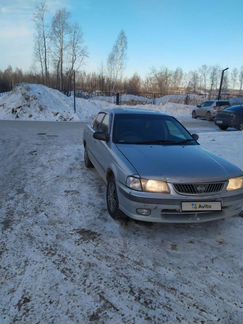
214,105,243,130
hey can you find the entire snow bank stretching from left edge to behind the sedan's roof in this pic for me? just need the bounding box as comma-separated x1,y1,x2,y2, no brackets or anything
0,84,194,122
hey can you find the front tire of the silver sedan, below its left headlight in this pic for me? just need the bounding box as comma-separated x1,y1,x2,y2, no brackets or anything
106,176,121,219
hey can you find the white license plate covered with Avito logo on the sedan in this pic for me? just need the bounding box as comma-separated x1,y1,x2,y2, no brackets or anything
181,201,222,212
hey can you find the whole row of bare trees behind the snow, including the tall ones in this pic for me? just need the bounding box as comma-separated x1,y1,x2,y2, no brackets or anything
0,1,243,96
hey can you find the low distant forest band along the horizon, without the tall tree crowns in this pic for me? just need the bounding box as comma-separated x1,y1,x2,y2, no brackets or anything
0,65,243,97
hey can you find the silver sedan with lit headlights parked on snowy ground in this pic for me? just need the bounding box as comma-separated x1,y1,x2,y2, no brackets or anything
83,109,243,223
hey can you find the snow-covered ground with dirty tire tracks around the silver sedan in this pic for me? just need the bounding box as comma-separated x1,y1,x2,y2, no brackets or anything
0,119,243,324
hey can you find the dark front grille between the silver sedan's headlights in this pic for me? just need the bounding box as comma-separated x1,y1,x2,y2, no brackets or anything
174,182,224,195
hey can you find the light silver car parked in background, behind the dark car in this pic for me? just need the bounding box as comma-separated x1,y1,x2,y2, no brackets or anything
192,100,230,120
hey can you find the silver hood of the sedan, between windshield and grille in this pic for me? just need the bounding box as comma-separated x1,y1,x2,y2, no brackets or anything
117,144,242,182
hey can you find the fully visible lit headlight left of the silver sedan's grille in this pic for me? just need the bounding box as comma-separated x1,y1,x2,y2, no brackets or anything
127,176,170,193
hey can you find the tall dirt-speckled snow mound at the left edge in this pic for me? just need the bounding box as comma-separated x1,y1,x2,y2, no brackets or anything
0,83,79,121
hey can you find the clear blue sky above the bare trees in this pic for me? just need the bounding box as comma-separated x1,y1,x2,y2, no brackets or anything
0,0,243,76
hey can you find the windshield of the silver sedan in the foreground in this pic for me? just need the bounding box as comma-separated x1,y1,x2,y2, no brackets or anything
113,114,197,145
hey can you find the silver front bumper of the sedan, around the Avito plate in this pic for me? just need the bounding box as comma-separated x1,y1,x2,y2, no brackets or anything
118,184,243,223
